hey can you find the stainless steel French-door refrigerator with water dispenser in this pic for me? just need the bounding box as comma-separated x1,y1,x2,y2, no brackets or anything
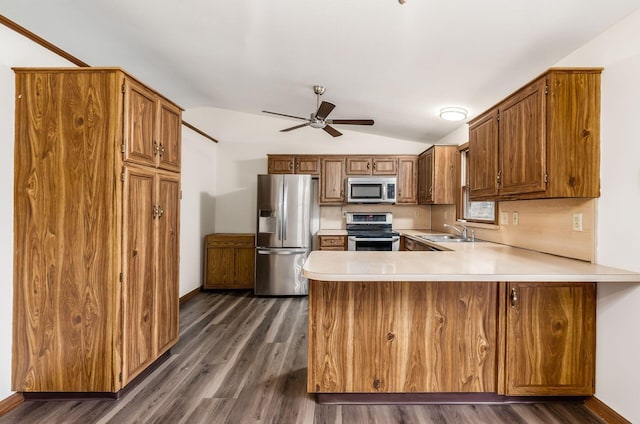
255,174,317,296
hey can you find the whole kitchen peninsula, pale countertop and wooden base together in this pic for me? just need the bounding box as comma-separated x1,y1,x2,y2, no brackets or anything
304,237,640,402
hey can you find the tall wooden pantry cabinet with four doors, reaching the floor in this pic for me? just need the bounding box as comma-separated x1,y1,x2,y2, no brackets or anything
12,68,181,393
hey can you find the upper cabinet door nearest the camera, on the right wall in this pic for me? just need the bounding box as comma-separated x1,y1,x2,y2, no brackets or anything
498,79,546,195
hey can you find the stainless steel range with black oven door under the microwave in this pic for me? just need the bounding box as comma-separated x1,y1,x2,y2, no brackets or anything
346,212,400,251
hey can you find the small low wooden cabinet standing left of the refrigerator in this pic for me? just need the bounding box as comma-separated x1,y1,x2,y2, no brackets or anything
203,233,255,289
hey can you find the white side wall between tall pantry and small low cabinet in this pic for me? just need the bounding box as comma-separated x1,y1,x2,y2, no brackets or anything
180,126,217,296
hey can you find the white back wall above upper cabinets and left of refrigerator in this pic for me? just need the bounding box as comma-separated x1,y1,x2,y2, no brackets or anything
184,108,430,233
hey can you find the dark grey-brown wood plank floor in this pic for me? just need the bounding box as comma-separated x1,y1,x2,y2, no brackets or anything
0,292,602,424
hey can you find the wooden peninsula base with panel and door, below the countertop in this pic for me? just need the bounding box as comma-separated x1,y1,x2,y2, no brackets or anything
307,280,595,396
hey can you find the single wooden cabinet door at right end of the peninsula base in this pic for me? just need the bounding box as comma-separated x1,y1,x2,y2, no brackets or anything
505,283,596,396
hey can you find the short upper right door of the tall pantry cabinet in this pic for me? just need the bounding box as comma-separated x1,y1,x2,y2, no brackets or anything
158,99,182,172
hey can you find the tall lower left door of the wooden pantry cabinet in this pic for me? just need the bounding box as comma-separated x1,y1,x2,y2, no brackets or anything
122,167,156,384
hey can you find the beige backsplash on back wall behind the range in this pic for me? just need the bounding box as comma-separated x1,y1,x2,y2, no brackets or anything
320,205,431,230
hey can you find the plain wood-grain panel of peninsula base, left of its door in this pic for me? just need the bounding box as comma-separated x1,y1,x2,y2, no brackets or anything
307,280,497,393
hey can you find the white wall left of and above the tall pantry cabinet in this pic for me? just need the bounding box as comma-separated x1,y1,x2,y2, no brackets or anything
0,25,73,400
